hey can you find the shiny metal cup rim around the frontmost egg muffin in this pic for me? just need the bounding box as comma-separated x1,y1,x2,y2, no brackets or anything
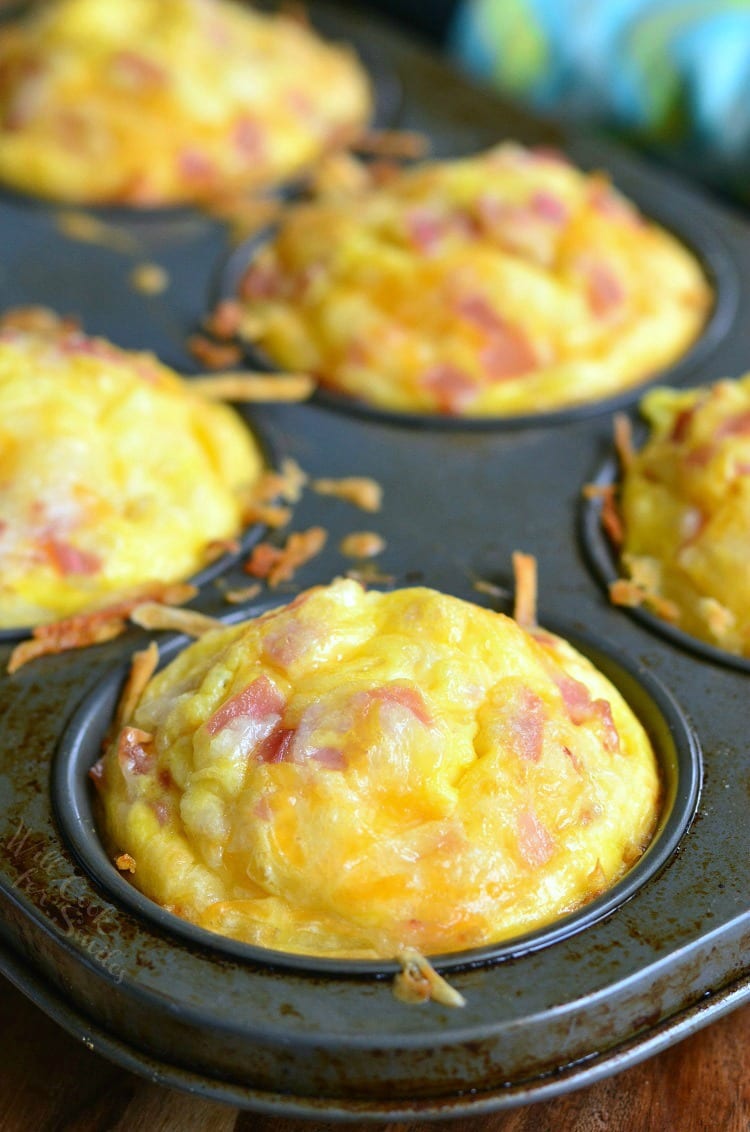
52,606,701,975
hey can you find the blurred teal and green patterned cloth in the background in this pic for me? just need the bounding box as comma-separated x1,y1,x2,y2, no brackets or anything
450,0,750,201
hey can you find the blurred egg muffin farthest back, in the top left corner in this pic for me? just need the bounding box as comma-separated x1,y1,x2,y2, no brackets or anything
0,0,372,205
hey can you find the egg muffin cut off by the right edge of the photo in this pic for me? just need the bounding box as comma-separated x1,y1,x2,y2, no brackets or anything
612,375,750,657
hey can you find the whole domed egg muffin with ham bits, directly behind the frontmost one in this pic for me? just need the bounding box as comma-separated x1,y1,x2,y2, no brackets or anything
240,143,713,417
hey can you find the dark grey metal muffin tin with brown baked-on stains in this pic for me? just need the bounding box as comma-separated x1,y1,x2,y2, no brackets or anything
0,6,750,1121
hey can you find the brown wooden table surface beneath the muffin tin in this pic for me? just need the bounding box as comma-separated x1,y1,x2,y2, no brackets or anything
0,978,750,1132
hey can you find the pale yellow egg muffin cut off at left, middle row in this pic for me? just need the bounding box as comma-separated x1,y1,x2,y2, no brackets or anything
0,315,264,628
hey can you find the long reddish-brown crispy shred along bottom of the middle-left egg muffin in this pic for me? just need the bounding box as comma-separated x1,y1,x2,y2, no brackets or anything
7,582,198,675
